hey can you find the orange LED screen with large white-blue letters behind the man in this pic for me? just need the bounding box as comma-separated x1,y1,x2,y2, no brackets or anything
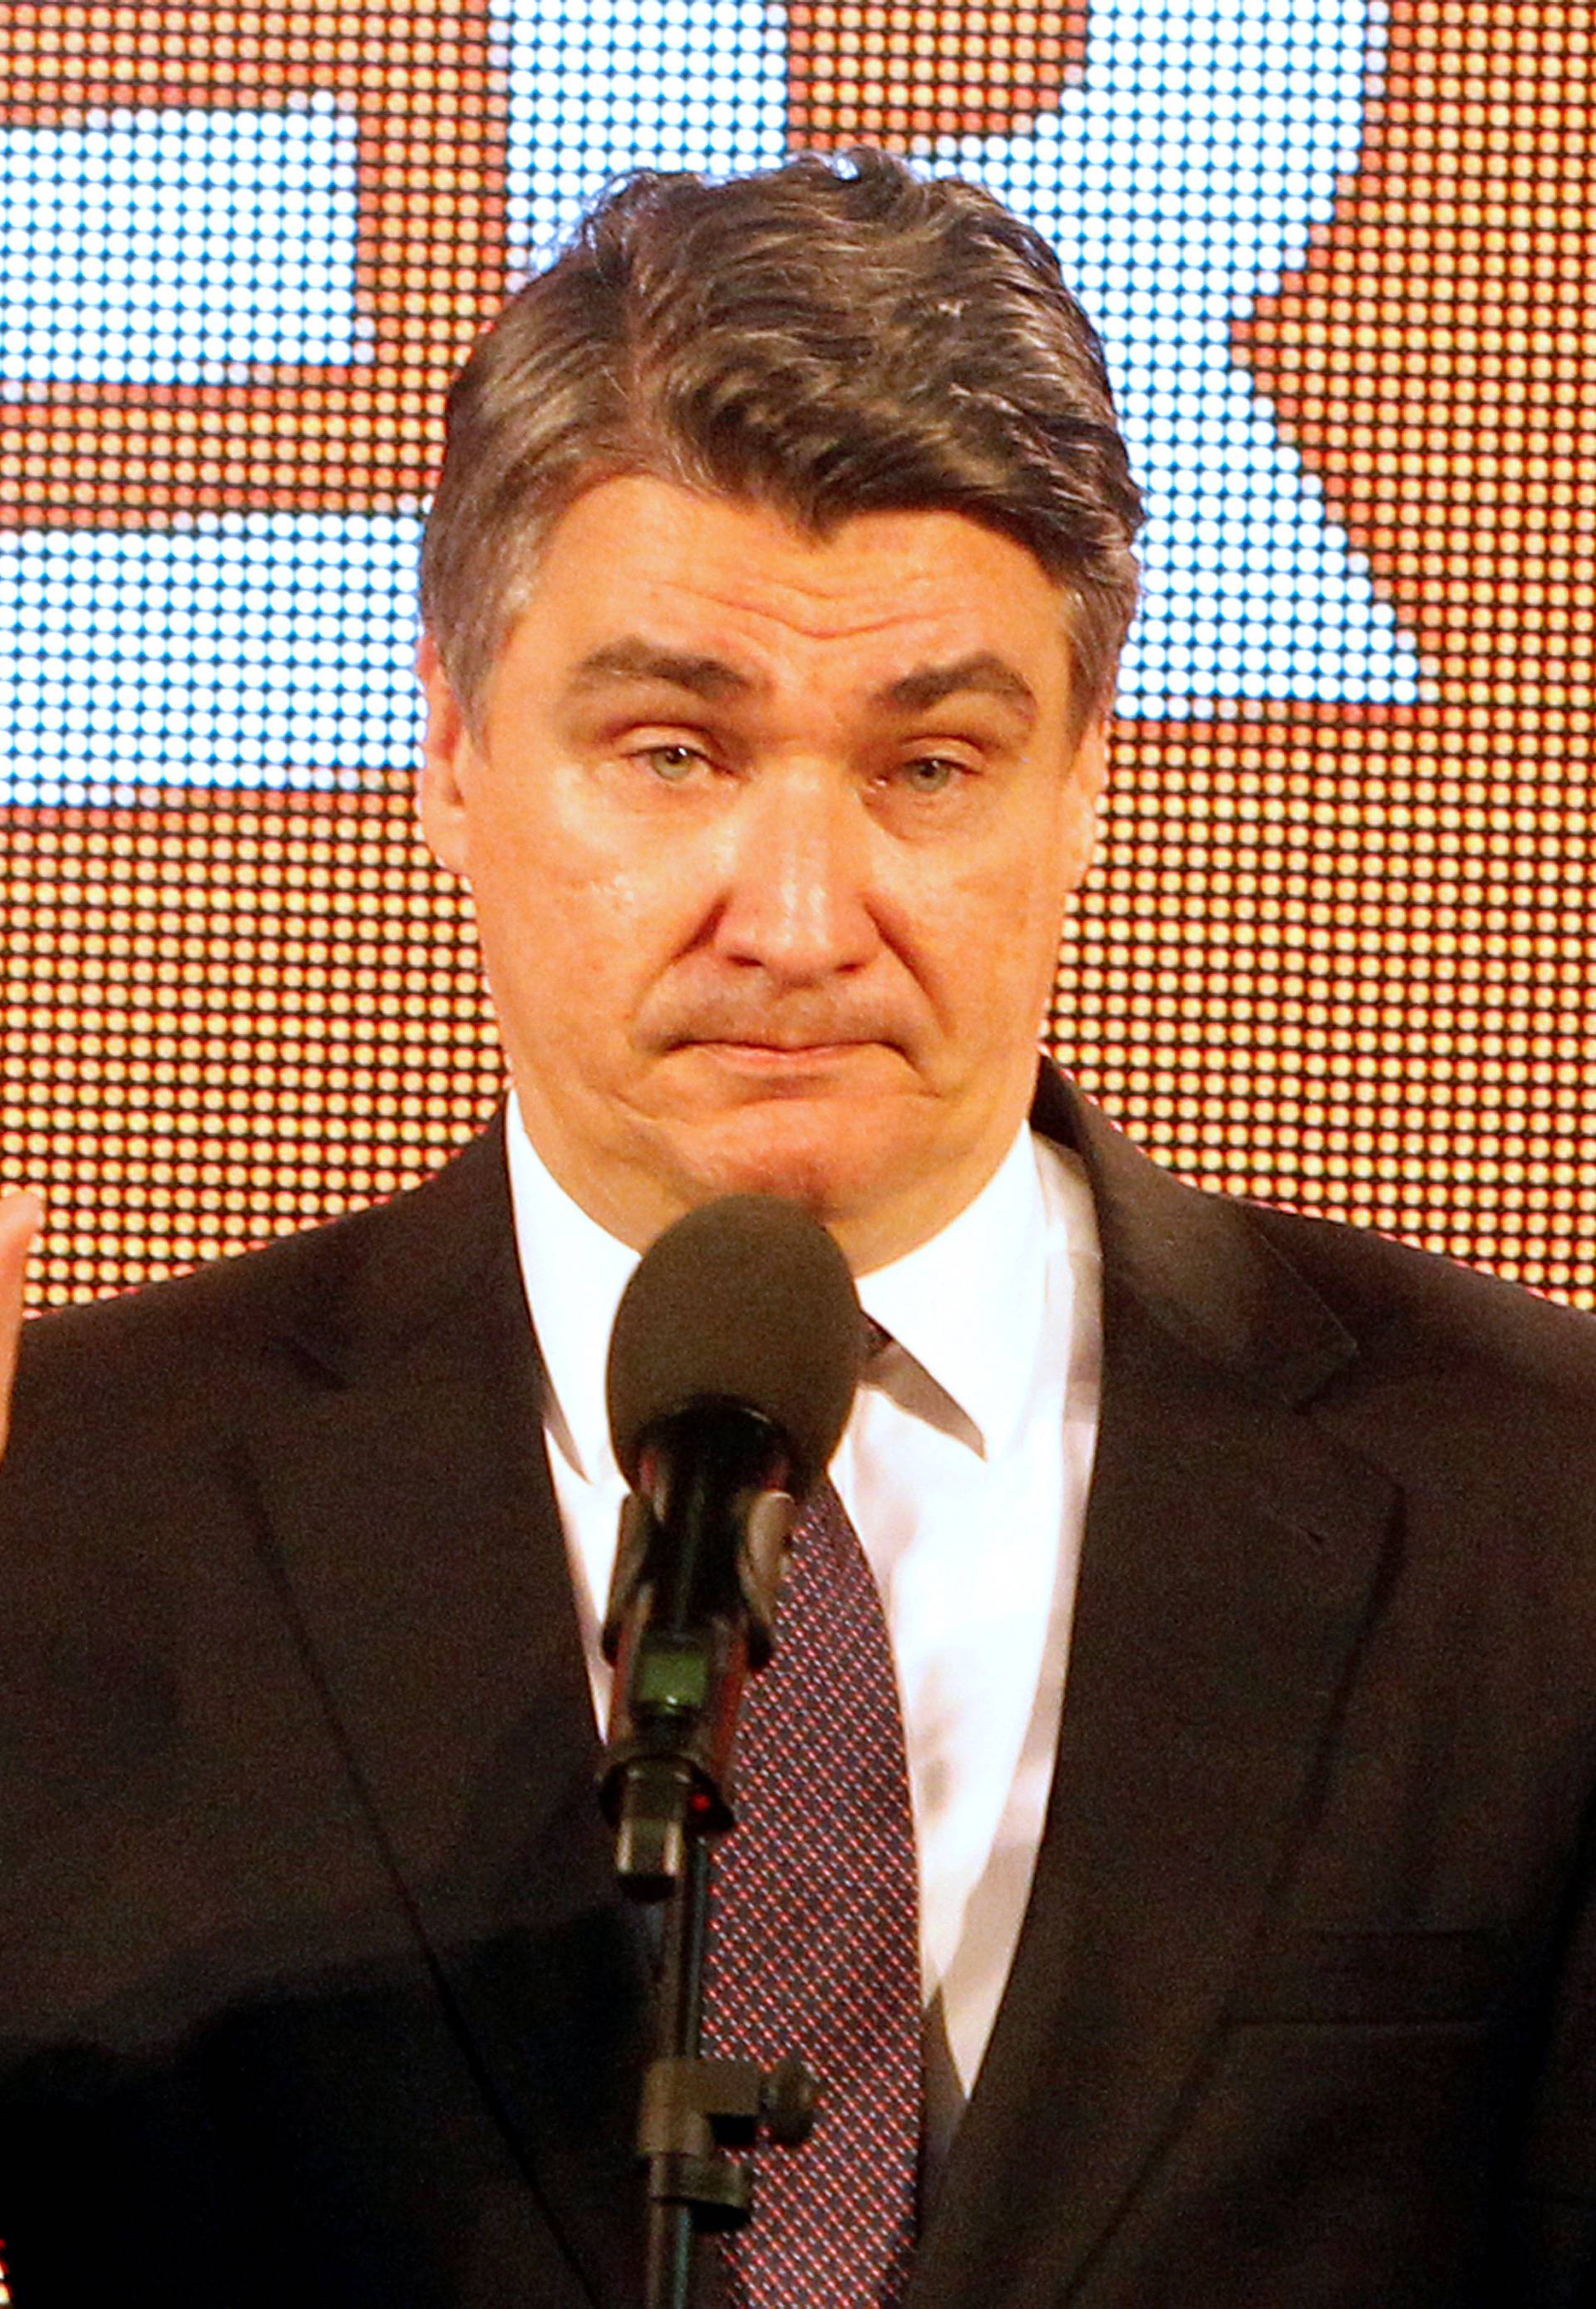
0,0,1596,1305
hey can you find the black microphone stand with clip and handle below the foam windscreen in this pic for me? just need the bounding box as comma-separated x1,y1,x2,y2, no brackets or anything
600,1411,815,2309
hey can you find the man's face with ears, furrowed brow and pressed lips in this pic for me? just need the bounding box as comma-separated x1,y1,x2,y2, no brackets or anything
422,478,1101,1273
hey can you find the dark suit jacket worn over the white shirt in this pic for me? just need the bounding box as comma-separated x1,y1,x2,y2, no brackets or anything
0,1076,1596,2309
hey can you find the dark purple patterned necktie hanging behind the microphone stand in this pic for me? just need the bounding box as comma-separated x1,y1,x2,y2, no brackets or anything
704,1482,922,2309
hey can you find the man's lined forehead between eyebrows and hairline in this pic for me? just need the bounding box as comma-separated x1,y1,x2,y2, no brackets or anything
501,475,1067,702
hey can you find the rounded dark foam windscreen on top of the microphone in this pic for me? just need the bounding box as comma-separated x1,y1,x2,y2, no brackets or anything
608,1194,864,1494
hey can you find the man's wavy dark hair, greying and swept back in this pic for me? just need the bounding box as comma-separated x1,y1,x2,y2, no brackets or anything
421,150,1141,725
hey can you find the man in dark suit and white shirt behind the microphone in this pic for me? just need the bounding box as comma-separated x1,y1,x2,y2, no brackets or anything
0,161,1596,2309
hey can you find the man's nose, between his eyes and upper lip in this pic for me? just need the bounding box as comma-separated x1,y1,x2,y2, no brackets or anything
714,765,880,988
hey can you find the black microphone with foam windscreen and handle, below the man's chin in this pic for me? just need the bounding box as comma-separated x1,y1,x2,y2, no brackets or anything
600,1194,864,1900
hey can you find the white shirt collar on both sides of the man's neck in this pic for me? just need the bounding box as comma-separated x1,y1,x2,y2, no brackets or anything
506,1095,1048,1482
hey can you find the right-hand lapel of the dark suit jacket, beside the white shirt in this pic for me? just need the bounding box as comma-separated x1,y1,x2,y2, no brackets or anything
910,1078,1392,2309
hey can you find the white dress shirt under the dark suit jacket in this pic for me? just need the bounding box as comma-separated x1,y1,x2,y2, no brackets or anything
508,1101,1101,2149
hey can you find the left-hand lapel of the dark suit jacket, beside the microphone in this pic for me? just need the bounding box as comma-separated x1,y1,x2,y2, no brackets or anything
232,1129,647,2302
